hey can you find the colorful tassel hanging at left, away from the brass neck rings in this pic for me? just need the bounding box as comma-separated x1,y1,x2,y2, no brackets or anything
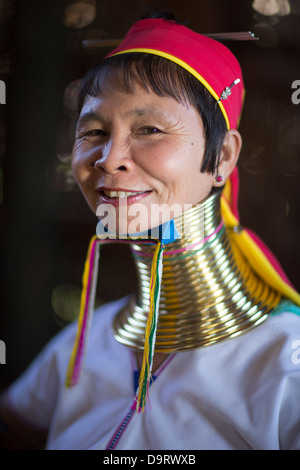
65,235,100,387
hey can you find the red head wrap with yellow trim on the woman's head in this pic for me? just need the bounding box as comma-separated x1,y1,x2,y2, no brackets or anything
107,18,244,129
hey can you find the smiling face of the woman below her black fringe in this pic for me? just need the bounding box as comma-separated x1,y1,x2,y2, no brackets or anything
72,82,218,237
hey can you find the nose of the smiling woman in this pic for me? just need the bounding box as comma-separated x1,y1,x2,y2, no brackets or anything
94,139,134,174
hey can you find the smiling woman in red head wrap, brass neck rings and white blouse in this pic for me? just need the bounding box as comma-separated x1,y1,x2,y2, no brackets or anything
3,13,300,450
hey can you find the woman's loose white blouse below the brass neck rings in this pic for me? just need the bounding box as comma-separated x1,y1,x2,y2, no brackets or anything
5,298,300,450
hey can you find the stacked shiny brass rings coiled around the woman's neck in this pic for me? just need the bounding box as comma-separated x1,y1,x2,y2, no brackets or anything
114,191,280,353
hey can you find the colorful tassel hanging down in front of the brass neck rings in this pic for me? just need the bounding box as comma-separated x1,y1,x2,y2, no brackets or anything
136,241,165,412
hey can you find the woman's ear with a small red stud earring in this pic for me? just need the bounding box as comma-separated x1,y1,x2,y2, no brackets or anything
213,129,242,187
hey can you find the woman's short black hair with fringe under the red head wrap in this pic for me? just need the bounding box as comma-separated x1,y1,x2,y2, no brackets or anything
78,13,227,173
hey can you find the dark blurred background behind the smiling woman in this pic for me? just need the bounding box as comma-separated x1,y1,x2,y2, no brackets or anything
0,0,300,390
